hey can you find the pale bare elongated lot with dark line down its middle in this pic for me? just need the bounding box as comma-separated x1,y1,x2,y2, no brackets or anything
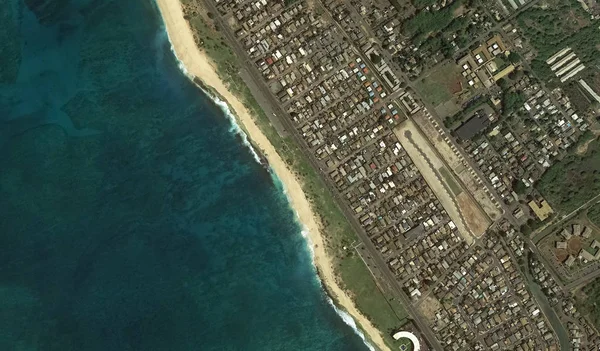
394,120,489,244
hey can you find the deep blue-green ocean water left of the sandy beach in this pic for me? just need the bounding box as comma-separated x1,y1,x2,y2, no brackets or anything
0,0,366,351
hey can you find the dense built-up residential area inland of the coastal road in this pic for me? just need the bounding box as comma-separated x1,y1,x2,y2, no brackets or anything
192,0,600,351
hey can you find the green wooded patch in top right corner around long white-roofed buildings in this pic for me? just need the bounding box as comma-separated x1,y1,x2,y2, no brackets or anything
517,0,600,80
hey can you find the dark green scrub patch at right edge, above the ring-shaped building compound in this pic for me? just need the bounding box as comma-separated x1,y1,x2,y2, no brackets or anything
537,140,600,213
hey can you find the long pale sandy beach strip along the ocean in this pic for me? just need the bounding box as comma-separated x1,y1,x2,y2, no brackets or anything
156,0,389,350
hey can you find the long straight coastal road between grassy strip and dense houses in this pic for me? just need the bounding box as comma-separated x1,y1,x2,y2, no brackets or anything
204,0,443,351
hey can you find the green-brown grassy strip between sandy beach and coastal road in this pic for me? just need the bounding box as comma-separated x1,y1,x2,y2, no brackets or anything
188,6,407,348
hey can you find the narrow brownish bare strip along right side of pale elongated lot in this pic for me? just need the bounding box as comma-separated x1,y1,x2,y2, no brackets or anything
414,113,502,221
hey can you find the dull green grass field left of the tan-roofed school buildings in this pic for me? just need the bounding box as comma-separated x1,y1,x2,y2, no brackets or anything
415,62,460,106
